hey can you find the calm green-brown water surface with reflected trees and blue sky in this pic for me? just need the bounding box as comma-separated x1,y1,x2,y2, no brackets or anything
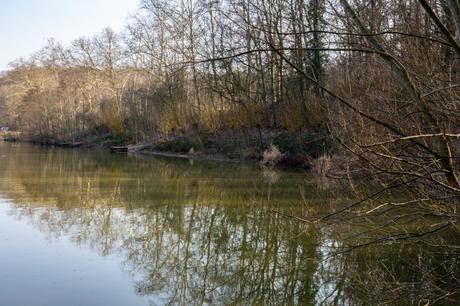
0,144,452,306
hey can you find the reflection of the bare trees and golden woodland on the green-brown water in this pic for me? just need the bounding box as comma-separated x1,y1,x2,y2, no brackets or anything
0,145,456,305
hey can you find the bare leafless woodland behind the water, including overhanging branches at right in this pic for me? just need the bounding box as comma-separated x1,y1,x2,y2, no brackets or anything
0,0,460,302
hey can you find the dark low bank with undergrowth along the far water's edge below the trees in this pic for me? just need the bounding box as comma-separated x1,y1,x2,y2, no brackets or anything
0,127,336,170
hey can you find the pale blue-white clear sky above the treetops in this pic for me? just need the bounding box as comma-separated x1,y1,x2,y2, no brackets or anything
0,0,140,71
